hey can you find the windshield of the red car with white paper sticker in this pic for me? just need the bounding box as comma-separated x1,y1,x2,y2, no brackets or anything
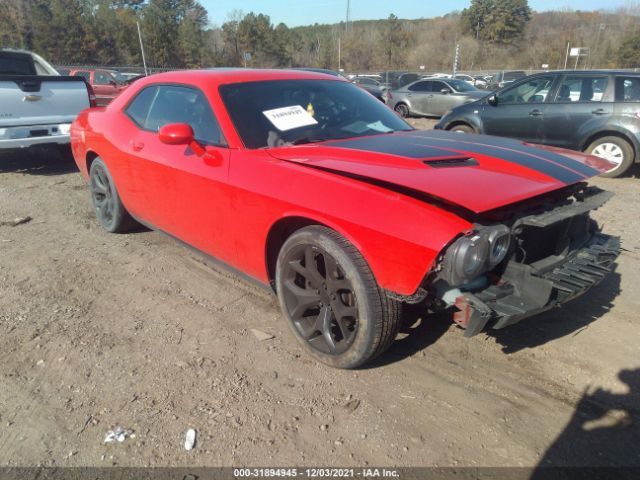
220,80,413,148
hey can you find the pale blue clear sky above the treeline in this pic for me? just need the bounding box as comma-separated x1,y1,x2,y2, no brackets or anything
200,0,637,27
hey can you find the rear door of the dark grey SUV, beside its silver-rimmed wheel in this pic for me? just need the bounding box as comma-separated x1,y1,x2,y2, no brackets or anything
540,74,614,149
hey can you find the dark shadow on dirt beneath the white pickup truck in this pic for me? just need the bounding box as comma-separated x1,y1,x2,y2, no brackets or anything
0,148,78,175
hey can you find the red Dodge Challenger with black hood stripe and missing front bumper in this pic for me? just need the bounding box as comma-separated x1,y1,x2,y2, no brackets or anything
71,69,619,368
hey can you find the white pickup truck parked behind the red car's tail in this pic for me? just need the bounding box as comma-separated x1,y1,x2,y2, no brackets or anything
0,49,95,152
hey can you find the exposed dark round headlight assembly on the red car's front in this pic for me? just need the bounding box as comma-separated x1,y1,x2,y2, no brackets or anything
440,225,511,286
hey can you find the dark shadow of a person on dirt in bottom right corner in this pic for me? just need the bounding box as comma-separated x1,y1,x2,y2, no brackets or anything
531,369,640,480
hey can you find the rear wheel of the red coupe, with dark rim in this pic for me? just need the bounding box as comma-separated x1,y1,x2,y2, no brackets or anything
89,157,137,233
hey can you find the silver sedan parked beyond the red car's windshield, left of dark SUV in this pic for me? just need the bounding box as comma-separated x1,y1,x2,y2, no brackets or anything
387,78,488,117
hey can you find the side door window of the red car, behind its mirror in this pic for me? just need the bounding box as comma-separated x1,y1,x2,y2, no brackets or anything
127,85,226,145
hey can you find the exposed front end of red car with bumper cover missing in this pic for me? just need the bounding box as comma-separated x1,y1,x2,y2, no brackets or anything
424,184,620,336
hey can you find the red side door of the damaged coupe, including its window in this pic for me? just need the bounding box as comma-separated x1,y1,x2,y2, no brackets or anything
120,85,234,262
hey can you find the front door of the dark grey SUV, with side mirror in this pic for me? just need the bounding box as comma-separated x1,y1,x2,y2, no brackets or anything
481,75,555,142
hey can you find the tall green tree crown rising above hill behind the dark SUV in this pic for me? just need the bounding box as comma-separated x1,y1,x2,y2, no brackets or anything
460,0,531,44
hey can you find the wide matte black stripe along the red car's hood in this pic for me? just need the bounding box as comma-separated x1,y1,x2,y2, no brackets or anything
326,131,599,184
